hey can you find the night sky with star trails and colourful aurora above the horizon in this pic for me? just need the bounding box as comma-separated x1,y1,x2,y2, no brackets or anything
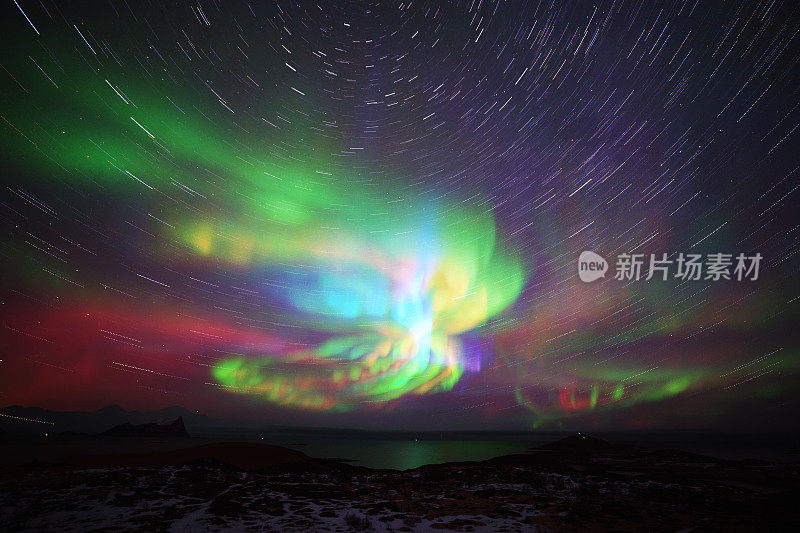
0,0,800,430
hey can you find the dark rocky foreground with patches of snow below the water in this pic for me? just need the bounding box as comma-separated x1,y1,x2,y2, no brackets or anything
0,435,800,531
